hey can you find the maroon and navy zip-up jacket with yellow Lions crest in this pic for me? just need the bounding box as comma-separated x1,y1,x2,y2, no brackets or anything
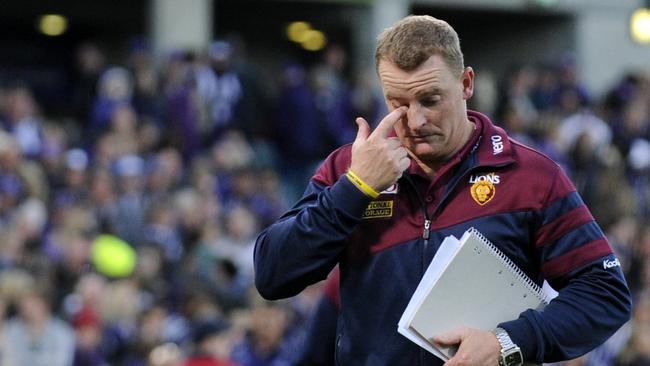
255,111,631,366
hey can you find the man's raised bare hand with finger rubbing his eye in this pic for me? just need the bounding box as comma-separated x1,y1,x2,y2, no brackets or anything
350,107,411,192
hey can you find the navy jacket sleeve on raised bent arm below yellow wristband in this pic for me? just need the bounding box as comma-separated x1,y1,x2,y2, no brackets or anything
254,175,370,299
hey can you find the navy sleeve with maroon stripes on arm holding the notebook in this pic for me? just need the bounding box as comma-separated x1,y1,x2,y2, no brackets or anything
499,167,631,363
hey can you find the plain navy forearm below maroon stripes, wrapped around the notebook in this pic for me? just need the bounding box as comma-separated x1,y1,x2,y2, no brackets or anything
500,261,631,363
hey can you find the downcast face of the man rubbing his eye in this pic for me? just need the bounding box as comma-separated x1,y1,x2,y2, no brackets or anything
377,55,474,163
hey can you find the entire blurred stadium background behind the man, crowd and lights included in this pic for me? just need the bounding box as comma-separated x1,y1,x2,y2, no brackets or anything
0,0,650,366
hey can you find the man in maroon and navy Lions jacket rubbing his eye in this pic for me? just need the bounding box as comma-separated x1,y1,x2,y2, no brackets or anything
255,16,631,366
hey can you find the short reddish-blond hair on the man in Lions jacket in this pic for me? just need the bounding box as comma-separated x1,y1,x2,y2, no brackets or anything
375,15,465,75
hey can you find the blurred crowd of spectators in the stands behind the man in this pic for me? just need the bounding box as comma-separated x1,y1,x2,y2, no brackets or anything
0,32,650,366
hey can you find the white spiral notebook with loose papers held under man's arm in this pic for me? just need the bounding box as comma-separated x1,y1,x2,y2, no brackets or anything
398,228,557,361
